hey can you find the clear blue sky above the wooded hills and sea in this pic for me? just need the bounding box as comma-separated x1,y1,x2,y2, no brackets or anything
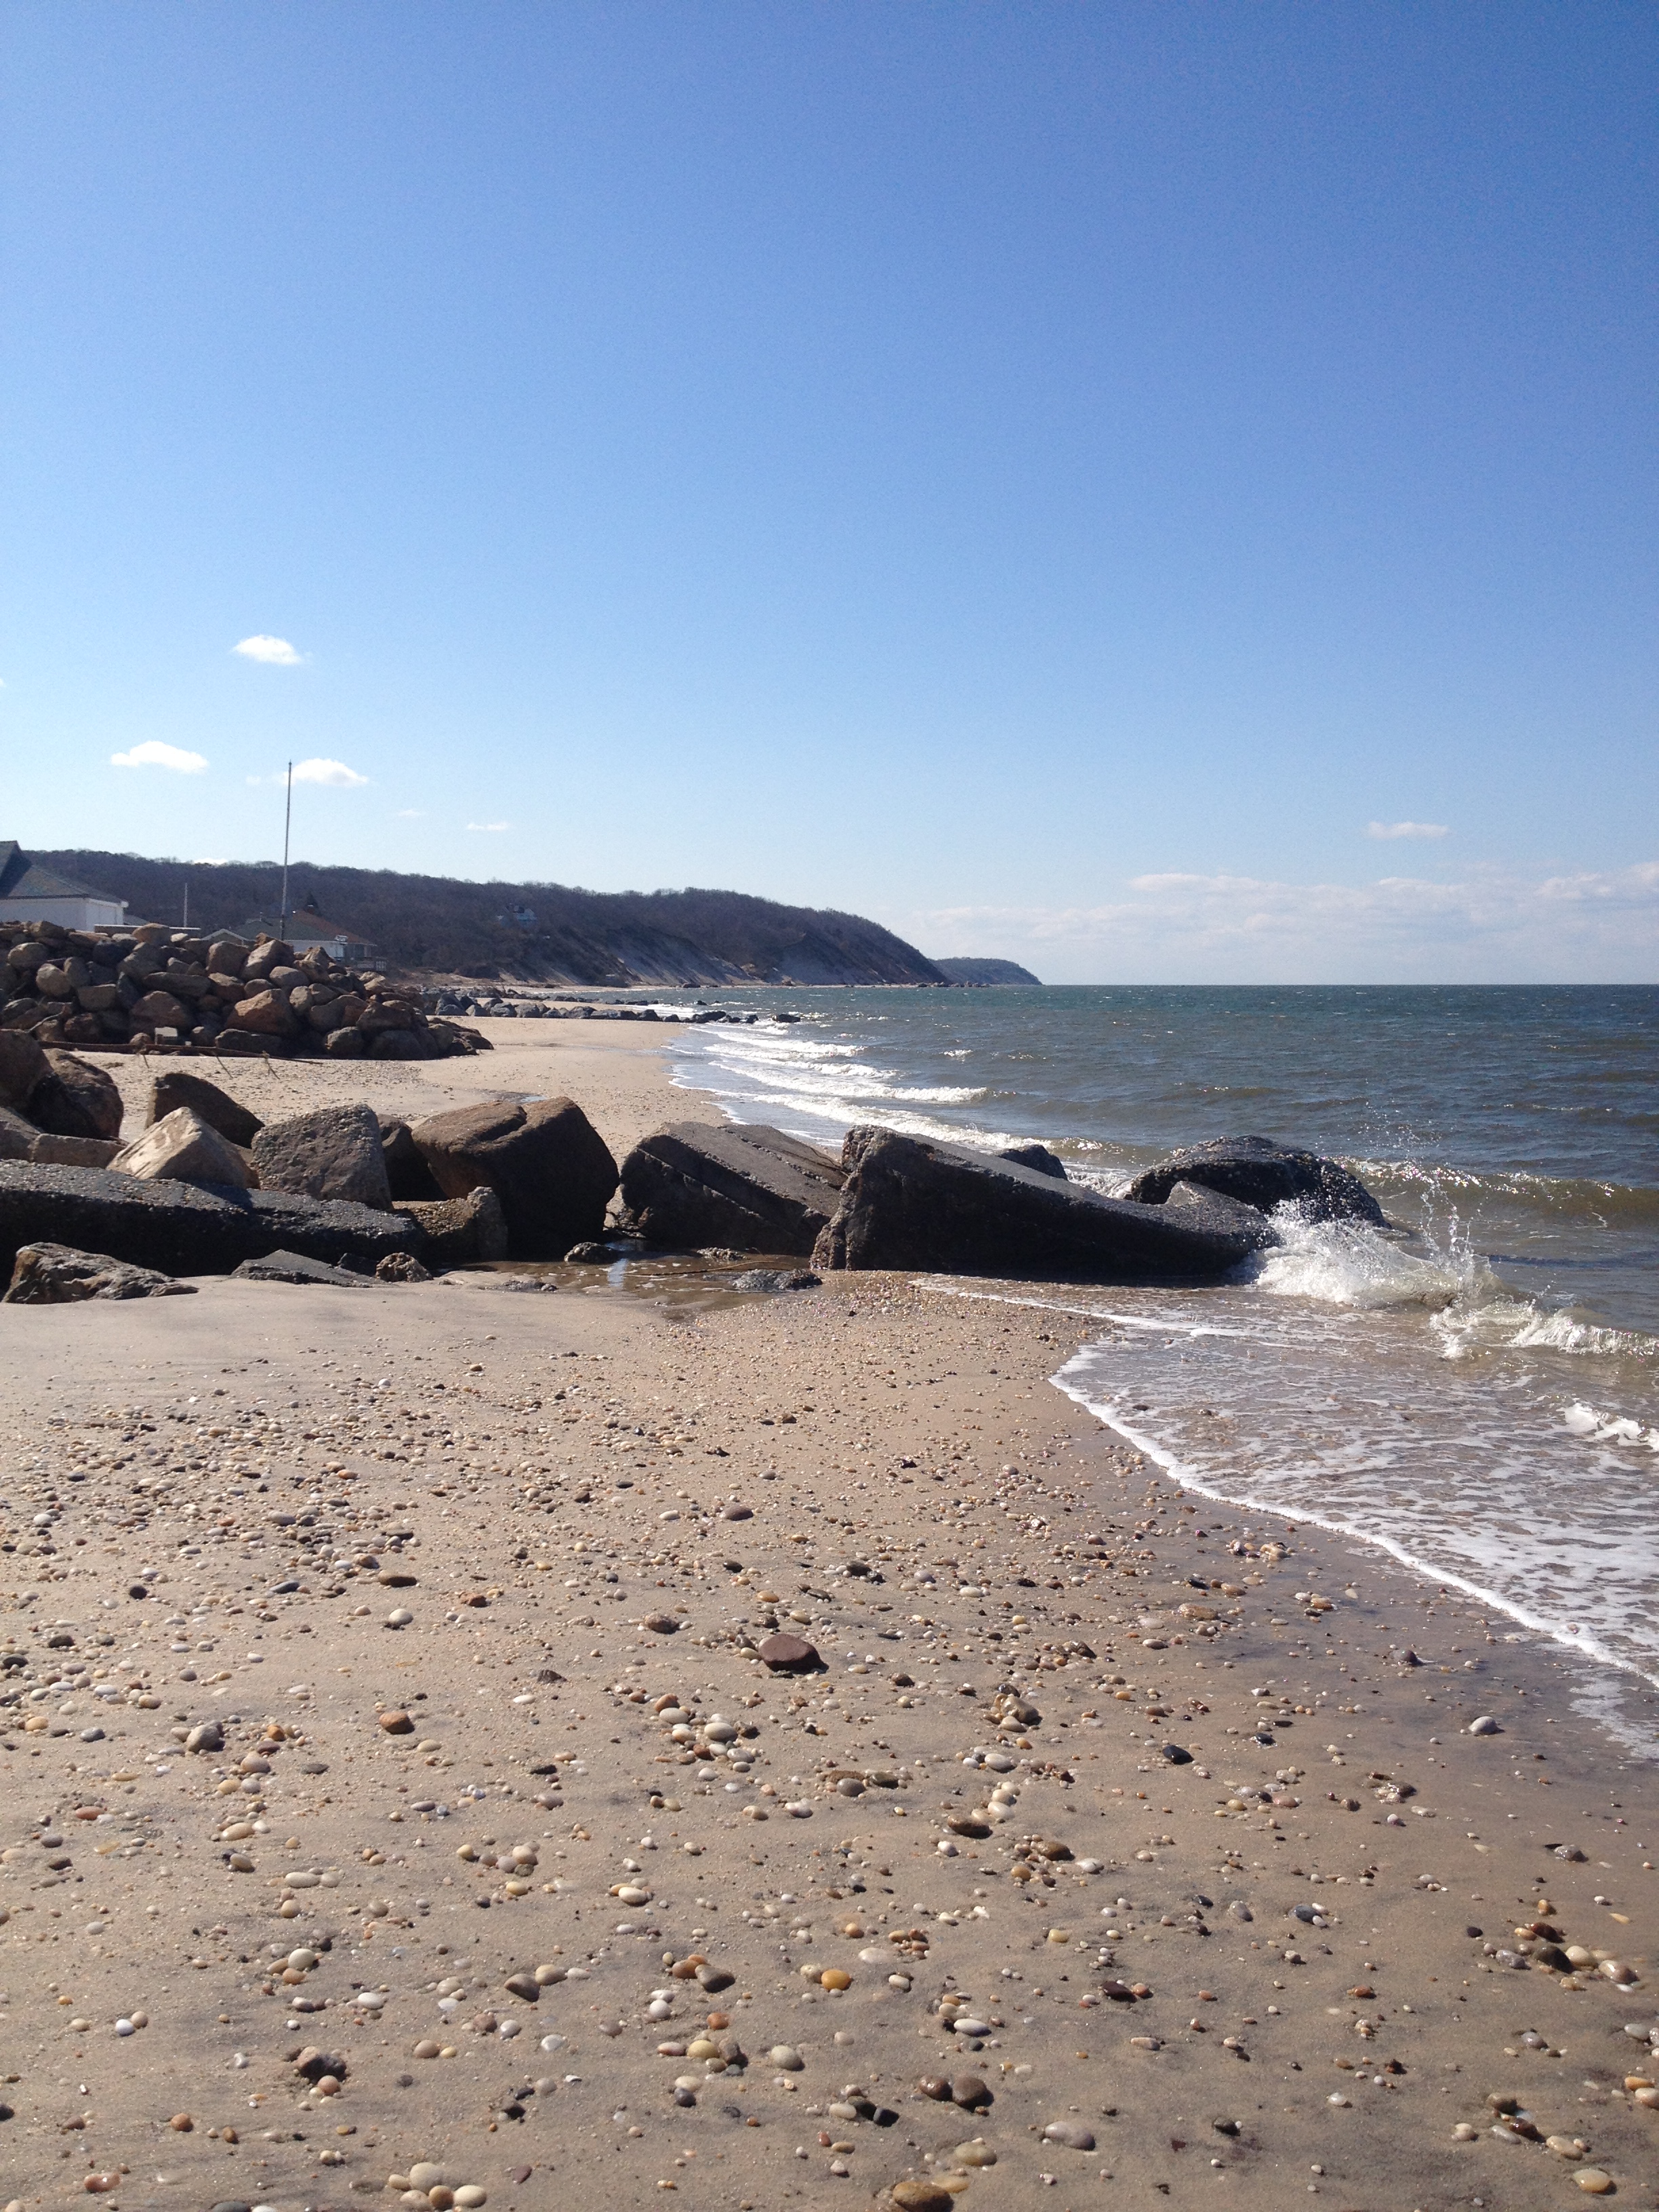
0,0,1659,982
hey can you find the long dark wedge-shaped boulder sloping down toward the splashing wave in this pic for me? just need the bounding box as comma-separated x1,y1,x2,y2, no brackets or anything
812,1126,1274,1283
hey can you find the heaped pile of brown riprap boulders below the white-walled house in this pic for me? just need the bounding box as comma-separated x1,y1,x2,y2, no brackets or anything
0,922,489,1052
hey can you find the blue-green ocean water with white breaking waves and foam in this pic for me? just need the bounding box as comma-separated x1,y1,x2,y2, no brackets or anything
670,987,1659,1757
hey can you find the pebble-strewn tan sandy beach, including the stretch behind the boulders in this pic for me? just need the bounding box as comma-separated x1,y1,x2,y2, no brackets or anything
0,1022,1659,2212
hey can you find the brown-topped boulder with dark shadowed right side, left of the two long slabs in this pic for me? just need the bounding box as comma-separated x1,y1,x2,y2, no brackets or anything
409,1099,617,1258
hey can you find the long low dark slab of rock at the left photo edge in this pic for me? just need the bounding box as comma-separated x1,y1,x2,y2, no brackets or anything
0,1159,422,1274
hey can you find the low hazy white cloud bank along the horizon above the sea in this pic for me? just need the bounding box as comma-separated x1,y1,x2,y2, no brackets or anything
905,861,1659,982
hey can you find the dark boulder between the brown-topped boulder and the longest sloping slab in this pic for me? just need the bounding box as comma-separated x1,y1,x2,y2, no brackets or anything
621,1122,858,1258
